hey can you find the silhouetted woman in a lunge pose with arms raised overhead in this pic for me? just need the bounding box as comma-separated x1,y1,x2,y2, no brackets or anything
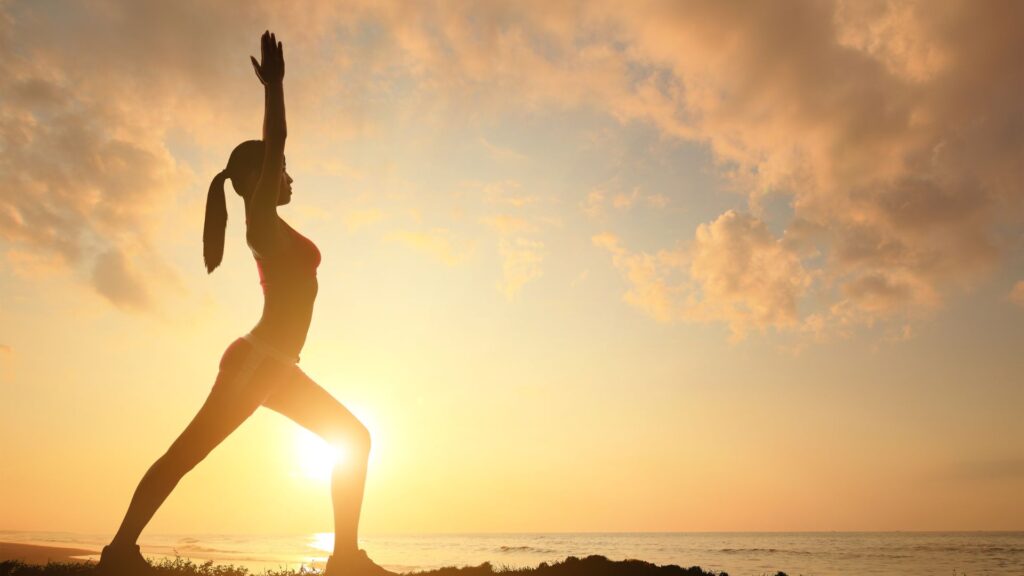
97,32,394,576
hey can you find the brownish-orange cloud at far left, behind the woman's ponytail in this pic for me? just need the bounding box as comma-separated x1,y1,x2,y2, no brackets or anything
0,58,180,307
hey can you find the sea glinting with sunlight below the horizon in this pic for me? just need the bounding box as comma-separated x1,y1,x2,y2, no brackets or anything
0,531,1024,576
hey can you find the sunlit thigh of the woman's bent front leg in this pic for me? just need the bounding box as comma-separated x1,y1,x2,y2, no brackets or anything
263,366,369,443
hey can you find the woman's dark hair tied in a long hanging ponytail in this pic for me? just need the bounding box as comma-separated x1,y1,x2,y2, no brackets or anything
203,140,263,274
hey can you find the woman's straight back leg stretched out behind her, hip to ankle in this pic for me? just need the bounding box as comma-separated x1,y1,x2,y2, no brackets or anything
111,340,275,547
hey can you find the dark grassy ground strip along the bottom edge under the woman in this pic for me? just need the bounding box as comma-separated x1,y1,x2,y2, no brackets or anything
0,556,785,576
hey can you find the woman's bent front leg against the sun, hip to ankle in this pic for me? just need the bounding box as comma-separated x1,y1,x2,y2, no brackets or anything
263,366,370,558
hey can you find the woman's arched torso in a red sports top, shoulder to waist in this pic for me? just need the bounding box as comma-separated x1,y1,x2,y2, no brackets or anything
252,218,321,357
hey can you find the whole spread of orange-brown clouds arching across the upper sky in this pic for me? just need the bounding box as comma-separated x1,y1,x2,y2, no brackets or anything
0,1,1024,334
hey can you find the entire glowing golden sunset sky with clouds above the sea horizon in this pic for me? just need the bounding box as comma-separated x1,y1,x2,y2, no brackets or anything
0,0,1024,534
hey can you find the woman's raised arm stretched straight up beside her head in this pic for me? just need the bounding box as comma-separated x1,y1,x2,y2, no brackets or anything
246,31,288,256
